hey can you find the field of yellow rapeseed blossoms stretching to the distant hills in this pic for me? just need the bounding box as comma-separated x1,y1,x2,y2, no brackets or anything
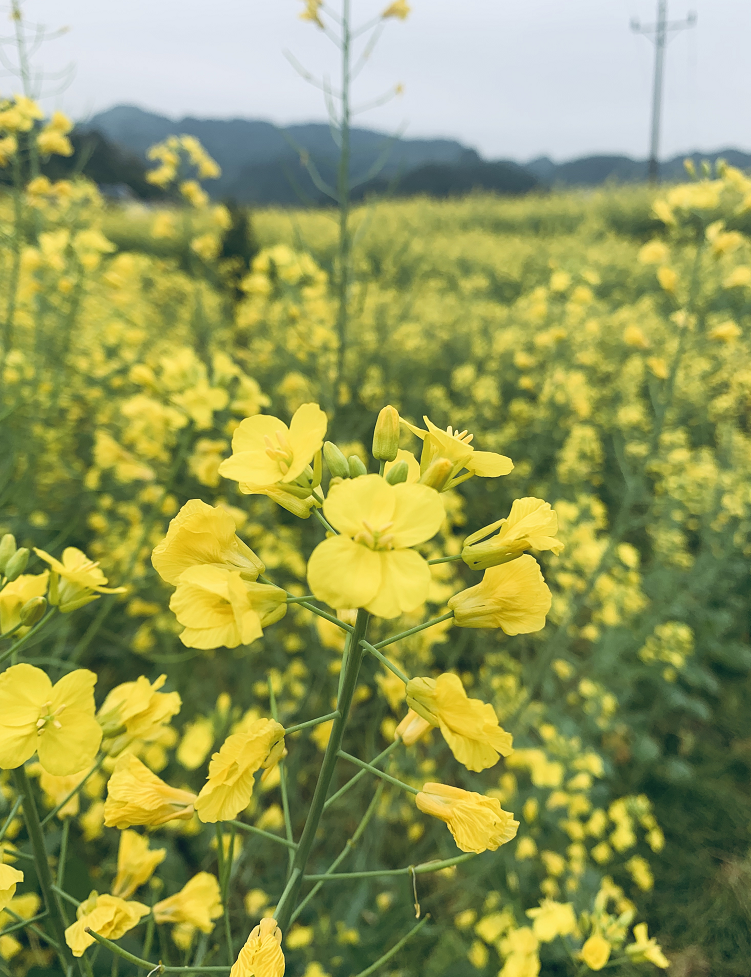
0,98,751,977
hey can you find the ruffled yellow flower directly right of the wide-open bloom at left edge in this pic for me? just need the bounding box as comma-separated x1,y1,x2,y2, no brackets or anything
97,675,182,756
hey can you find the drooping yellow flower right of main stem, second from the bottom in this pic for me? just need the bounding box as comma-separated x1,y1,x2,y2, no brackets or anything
407,672,512,771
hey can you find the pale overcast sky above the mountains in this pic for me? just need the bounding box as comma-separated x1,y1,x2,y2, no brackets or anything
10,0,751,160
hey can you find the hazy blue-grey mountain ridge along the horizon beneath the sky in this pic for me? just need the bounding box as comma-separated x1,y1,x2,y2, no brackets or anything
78,105,751,205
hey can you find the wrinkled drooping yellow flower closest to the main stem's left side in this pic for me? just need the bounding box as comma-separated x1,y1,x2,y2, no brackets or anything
196,719,284,823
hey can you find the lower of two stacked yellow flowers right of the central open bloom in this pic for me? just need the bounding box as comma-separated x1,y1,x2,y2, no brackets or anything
448,554,552,634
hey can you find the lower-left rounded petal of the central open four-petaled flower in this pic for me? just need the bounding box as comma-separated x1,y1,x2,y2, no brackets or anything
308,532,382,613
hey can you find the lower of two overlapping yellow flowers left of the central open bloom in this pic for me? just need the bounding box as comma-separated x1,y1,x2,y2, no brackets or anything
169,566,287,649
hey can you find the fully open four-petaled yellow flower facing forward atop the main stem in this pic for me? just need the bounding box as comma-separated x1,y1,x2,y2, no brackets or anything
308,475,444,617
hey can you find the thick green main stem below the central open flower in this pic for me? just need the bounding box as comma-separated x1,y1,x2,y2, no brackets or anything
276,609,369,932
